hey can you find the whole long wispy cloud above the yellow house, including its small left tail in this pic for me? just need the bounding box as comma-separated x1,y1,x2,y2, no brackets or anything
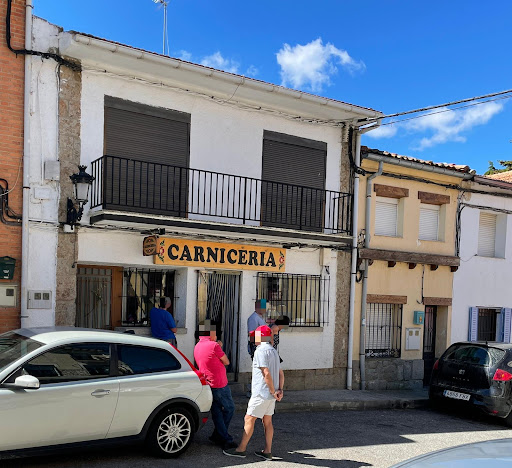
367,102,503,151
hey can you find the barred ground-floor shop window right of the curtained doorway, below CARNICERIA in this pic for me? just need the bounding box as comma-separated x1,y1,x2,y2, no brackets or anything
256,273,330,327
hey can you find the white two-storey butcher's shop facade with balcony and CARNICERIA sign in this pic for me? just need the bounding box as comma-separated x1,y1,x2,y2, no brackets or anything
22,18,379,388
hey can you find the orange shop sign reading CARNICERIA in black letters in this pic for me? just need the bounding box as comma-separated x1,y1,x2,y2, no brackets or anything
153,238,286,272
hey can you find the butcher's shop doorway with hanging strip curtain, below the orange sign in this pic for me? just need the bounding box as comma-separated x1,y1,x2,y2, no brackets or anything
196,271,240,381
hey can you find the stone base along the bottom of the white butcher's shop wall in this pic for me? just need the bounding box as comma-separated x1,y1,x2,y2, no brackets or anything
238,367,347,390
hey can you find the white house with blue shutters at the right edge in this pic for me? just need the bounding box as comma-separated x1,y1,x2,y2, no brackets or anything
451,176,512,343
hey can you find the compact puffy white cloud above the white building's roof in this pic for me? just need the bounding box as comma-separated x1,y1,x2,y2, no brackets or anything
276,38,365,91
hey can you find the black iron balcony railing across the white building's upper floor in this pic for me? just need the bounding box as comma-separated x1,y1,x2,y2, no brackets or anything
91,156,352,234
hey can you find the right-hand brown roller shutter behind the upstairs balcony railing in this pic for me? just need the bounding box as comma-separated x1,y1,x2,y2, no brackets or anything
261,131,327,231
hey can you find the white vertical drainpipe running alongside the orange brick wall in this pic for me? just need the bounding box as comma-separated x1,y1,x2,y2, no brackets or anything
20,0,34,328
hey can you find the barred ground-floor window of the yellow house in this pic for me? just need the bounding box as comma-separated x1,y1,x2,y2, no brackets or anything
365,303,403,358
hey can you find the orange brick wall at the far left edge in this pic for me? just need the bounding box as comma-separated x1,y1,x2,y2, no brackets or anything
0,0,25,333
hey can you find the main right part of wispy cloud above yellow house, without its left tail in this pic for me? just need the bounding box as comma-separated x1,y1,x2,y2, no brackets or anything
405,102,503,151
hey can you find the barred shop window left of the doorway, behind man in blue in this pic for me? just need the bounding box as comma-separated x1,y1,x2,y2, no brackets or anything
123,268,180,327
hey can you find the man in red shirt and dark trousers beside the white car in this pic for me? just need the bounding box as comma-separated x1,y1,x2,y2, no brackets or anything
194,320,237,450
